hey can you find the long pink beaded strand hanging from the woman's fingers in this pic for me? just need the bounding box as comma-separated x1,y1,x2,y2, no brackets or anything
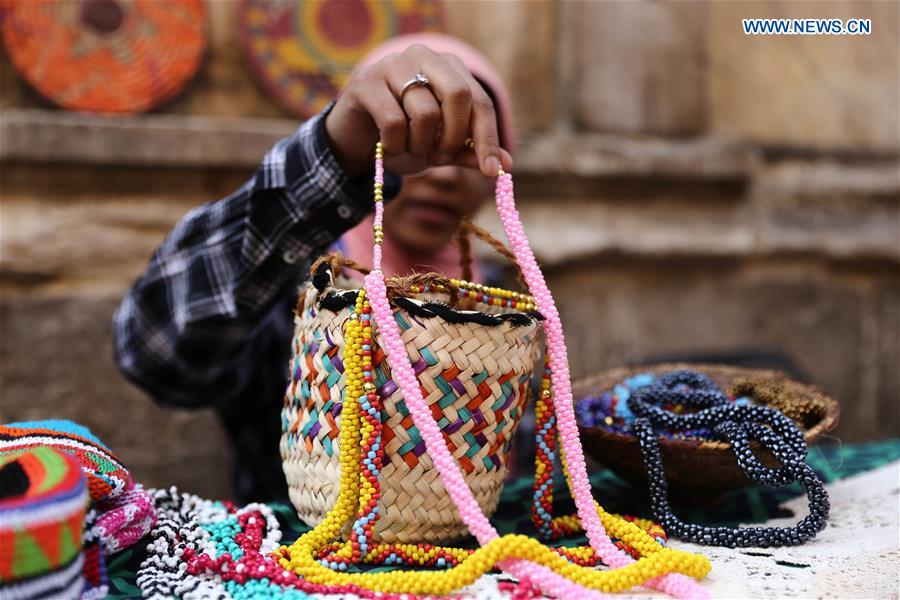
365,146,708,598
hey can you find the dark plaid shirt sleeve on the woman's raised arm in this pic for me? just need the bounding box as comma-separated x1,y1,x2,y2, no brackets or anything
113,107,387,406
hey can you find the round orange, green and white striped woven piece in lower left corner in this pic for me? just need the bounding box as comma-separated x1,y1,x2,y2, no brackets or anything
0,446,88,598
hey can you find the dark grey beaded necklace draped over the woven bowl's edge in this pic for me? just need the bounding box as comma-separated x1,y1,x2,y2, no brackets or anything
628,370,830,548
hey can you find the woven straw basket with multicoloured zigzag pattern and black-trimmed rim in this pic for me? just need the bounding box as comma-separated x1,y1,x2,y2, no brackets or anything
281,224,542,544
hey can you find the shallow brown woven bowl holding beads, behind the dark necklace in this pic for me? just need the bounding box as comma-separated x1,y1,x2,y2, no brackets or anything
572,363,840,499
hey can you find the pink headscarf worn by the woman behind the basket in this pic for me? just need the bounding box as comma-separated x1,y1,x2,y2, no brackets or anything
341,33,516,280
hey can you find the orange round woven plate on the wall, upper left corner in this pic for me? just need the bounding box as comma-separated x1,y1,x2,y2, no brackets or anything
0,0,208,113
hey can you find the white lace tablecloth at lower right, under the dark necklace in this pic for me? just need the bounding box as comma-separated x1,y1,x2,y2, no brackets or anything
458,461,900,599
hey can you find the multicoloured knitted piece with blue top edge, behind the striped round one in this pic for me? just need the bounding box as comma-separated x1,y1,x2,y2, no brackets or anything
0,421,156,598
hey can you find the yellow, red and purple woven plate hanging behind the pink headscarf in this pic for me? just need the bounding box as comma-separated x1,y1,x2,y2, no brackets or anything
238,0,444,118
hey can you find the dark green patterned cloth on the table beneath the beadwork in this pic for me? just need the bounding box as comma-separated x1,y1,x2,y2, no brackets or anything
107,439,900,598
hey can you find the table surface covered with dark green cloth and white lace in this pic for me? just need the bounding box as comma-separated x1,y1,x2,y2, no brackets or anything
107,440,900,598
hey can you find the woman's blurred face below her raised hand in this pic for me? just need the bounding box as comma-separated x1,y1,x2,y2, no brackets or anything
384,166,493,254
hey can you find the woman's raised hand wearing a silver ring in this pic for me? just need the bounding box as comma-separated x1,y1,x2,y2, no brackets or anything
325,44,512,177
